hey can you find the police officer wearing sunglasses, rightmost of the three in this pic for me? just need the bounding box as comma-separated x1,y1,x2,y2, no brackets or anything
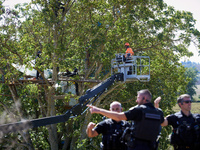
157,94,200,150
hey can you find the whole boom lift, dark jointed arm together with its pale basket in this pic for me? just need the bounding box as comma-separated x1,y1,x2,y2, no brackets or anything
0,54,150,134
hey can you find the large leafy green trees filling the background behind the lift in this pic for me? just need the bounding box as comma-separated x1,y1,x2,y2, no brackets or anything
0,0,200,150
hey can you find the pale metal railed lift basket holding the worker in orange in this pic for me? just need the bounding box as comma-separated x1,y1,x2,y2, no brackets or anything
111,53,150,82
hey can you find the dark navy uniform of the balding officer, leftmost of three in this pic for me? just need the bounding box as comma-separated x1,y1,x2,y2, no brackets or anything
94,119,130,150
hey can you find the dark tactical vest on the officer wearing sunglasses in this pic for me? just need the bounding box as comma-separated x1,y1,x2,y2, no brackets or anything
170,112,200,149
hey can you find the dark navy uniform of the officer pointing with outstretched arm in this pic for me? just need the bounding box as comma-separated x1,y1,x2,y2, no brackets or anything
125,103,164,150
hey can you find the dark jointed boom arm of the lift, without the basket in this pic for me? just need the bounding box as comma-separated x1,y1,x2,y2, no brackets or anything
0,73,124,134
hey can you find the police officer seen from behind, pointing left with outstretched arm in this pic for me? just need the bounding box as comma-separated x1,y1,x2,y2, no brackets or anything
88,89,164,150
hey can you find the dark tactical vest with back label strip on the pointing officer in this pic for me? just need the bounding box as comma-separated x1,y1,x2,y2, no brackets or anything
134,105,161,141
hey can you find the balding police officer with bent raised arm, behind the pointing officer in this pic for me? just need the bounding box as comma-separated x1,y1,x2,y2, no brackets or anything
86,101,129,150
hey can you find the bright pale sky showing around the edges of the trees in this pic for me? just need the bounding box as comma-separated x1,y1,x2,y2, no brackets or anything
4,0,200,63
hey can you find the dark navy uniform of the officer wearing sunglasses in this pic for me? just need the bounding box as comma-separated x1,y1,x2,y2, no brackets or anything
167,111,200,150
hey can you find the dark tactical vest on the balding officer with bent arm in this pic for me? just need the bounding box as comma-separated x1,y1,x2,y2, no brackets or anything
100,119,127,150
